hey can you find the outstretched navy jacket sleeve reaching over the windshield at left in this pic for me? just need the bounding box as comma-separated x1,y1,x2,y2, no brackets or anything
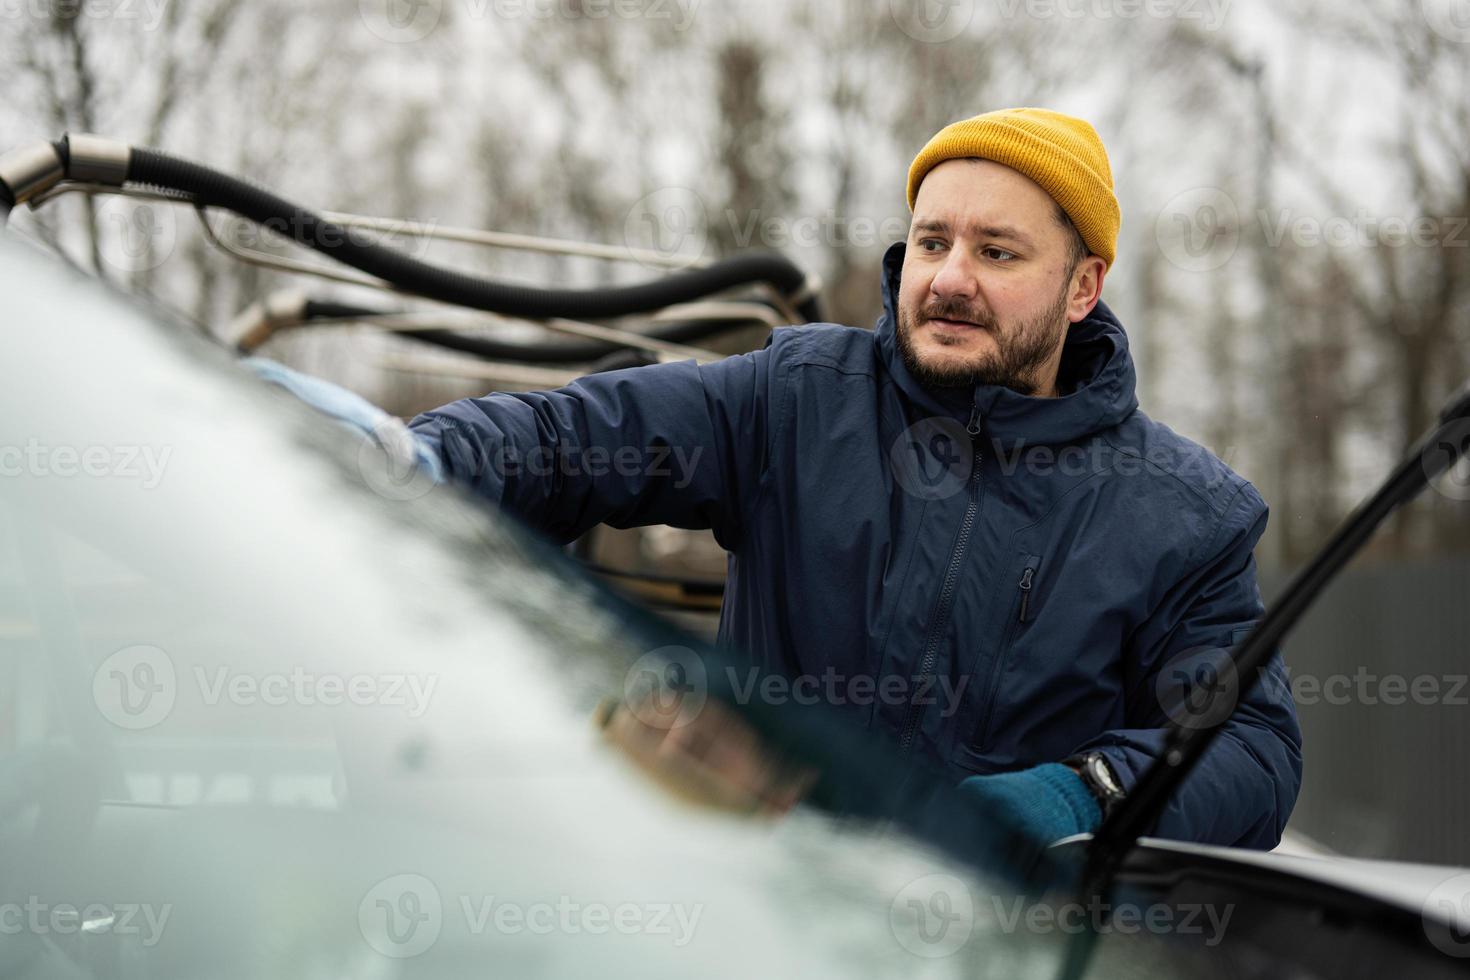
409,347,773,550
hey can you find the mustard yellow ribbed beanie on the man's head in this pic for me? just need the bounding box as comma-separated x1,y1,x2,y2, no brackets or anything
908,109,1122,267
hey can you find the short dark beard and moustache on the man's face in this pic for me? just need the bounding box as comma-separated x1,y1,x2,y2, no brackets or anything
898,279,1067,395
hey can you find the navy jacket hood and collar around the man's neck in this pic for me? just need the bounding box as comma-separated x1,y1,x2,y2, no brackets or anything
873,241,1138,447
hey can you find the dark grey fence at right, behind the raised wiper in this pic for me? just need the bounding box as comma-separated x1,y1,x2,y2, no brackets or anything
1261,557,1470,865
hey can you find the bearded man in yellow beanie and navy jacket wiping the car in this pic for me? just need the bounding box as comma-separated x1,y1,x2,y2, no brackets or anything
264,109,1301,848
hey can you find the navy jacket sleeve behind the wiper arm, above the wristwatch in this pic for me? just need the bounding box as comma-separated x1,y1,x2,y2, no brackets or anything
1078,483,1301,849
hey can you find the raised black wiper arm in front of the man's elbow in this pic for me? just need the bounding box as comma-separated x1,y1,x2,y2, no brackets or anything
1061,382,1470,977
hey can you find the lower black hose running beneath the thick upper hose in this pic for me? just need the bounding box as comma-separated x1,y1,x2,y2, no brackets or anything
303,300,766,364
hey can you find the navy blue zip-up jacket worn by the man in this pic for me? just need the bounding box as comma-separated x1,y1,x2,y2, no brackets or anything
410,244,1301,848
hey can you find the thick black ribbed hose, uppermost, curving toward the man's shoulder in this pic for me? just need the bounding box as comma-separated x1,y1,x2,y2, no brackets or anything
128,148,820,320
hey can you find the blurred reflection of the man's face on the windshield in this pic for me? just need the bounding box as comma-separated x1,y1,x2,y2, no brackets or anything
598,701,816,817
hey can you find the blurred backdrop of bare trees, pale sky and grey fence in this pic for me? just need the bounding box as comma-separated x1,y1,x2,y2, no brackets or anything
0,0,1470,864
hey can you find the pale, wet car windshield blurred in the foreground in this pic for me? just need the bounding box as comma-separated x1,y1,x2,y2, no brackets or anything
0,239,1217,977
